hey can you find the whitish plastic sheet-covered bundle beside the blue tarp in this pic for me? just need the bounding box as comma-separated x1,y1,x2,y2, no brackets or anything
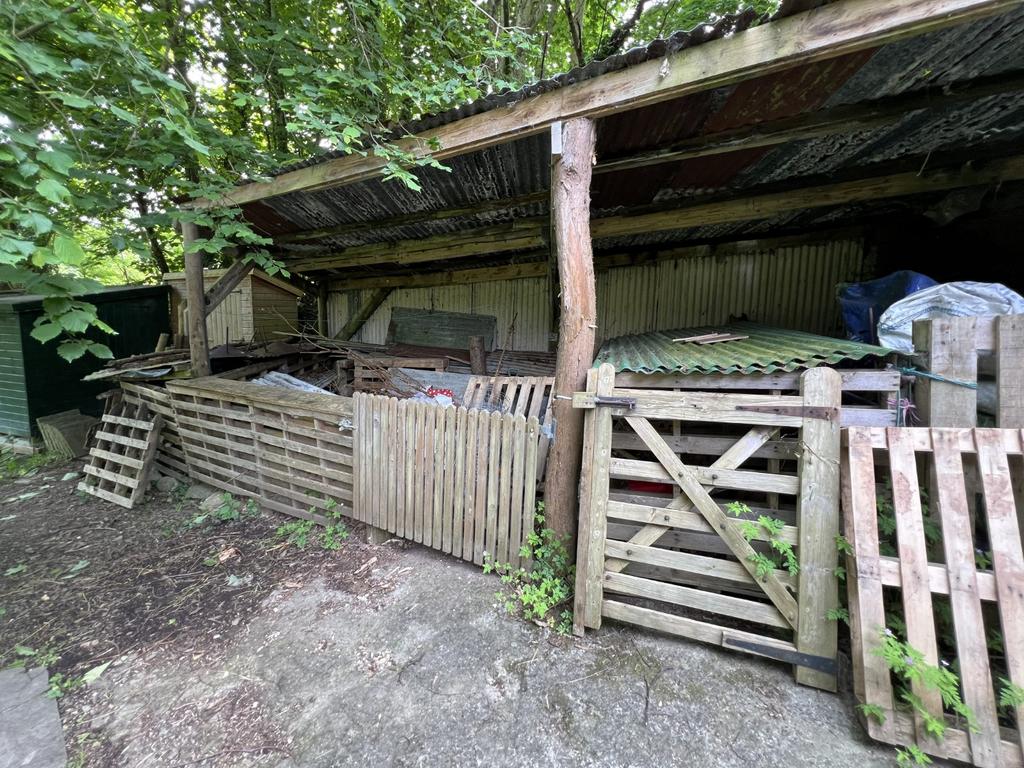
879,282,1024,354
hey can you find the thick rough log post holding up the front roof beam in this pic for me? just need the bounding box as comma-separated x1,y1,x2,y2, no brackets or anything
544,119,597,552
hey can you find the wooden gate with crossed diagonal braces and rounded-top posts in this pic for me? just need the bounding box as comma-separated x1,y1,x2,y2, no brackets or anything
573,365,841,690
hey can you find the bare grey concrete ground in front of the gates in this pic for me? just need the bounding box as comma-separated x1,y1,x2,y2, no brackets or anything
72,542,894,768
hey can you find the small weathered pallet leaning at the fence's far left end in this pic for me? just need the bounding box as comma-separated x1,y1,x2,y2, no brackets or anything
78,401,163,509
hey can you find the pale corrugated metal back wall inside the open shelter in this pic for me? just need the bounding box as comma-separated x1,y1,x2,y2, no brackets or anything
329,239,865,350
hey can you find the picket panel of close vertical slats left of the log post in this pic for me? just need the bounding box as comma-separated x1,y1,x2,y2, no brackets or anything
353,393,541,567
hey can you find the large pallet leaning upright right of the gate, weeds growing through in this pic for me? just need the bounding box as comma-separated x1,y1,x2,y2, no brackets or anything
842,427,1024,767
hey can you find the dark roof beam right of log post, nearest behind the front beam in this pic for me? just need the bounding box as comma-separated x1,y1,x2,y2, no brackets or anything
594,72,1024,174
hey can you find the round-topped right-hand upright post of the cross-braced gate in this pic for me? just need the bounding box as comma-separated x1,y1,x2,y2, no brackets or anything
797,368,843,691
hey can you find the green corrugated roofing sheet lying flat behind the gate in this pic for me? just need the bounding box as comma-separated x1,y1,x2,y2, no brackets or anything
595,323,891,374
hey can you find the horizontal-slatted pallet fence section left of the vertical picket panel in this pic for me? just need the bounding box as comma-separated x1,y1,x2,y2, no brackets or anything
167,377,354,521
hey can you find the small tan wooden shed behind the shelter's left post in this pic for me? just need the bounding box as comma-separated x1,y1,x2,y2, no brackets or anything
164,269,303,345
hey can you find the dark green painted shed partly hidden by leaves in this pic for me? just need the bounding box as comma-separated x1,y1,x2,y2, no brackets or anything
0,286,170,437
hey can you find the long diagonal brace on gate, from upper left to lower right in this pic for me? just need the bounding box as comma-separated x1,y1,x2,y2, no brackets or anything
626,416,800,632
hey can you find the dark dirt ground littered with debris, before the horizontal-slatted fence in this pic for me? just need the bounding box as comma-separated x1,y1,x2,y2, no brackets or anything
0,462,399,765
